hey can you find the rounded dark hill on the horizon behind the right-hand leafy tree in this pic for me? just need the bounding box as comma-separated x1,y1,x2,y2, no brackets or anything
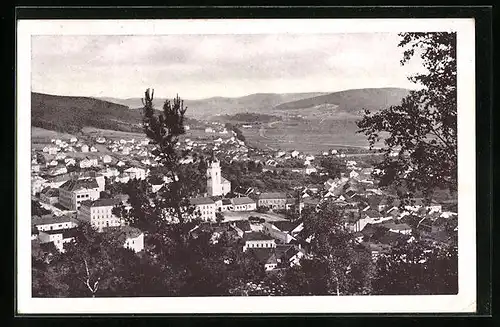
274,88,409,116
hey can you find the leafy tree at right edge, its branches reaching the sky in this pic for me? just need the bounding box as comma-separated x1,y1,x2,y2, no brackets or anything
357,32,457,199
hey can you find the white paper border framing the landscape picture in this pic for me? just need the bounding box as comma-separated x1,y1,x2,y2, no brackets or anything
16,18,476,314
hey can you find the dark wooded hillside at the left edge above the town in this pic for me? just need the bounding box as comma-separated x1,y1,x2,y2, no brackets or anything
31,92,142,133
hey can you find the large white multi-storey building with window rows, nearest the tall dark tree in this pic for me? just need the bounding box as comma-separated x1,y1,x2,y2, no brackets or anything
78,199,122,232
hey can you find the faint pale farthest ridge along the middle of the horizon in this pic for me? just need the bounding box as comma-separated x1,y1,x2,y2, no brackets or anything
101,92,327,119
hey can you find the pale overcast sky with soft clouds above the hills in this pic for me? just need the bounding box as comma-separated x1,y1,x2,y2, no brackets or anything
32,33,421,99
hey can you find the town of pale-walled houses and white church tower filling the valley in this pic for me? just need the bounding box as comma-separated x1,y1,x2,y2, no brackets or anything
31,116,458,290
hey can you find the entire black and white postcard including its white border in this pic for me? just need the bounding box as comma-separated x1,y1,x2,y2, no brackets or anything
17,19,476,313
